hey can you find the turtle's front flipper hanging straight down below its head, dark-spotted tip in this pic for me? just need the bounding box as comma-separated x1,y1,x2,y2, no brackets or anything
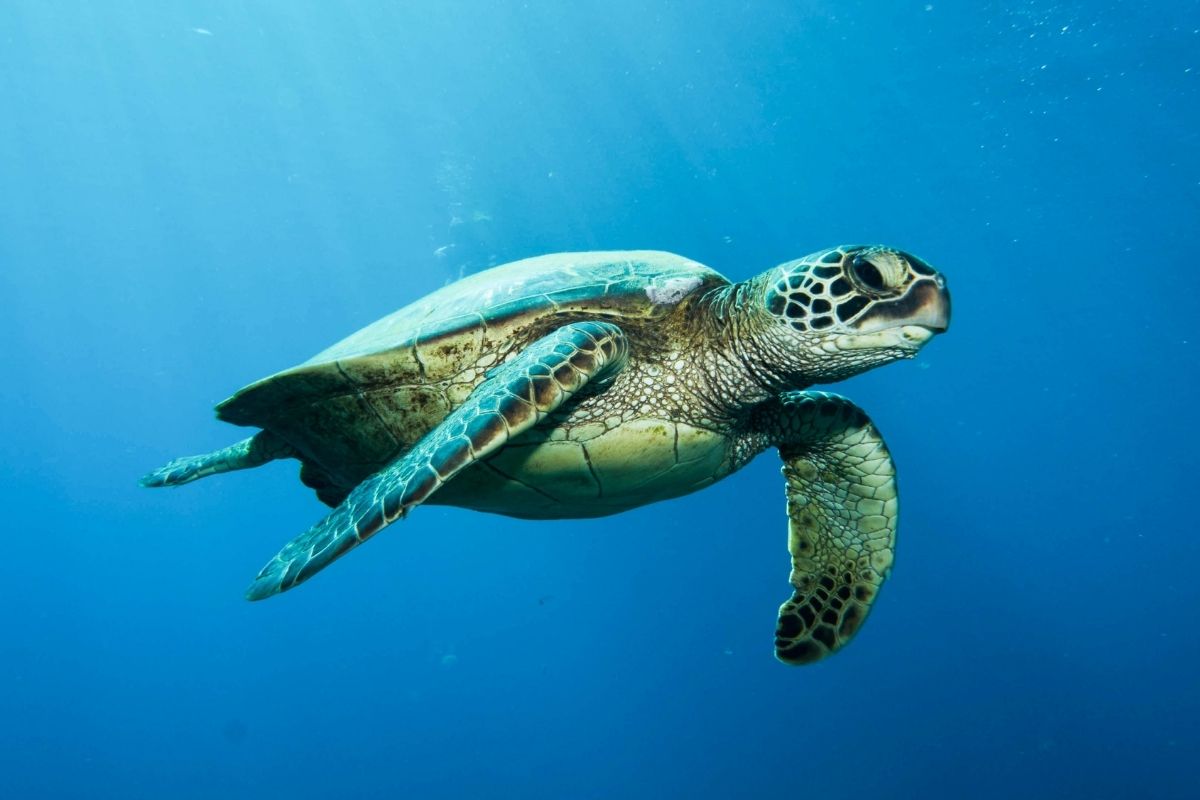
761,392,896,664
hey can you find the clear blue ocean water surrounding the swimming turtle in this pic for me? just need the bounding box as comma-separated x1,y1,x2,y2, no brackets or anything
0,0,1200,800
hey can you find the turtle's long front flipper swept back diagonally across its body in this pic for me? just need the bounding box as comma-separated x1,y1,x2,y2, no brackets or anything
246,321,629,600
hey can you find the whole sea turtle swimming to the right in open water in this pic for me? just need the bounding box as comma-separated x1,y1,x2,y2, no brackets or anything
142,246,950,663
